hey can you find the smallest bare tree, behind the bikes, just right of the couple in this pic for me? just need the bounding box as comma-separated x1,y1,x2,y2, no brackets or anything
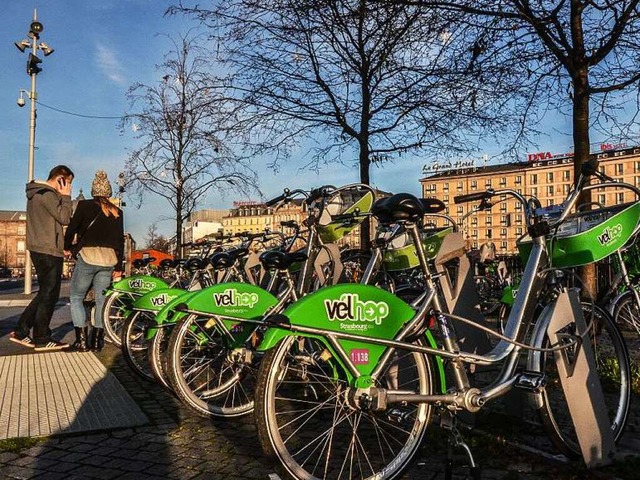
125,36,257,252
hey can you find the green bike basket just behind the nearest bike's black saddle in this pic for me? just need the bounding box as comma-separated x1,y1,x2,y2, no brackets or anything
383,227,453,271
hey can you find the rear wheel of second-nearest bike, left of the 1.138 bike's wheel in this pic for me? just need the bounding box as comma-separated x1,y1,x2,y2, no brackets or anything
167,314,256,418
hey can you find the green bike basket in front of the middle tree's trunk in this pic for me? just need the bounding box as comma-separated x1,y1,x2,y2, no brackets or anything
318,184,375,243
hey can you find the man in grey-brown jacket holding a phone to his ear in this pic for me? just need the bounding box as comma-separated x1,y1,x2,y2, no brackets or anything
10,165,73,351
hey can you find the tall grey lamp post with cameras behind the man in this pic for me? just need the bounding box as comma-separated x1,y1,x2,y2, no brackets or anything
15,9,53,294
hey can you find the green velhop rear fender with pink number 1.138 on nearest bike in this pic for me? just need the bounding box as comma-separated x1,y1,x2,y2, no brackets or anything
258,284,415,375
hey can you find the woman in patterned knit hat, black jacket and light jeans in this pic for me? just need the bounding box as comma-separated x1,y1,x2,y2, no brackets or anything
64,170,124,352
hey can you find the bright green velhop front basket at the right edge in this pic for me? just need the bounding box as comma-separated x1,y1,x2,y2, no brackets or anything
518,202,640,268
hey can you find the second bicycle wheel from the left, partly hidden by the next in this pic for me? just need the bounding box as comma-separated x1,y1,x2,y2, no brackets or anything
120,311,154,381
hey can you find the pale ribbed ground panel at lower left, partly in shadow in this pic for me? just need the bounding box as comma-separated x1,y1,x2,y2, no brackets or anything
0,352,149,439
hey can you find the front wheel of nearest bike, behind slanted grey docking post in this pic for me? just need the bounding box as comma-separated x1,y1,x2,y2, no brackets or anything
534,303,631,458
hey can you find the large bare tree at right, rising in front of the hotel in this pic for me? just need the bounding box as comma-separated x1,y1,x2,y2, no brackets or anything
399,0,640,180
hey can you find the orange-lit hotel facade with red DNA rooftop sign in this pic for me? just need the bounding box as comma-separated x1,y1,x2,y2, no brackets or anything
420,145,640,254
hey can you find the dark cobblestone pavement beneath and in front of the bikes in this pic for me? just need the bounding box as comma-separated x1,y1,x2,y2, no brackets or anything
0,306,640,480
